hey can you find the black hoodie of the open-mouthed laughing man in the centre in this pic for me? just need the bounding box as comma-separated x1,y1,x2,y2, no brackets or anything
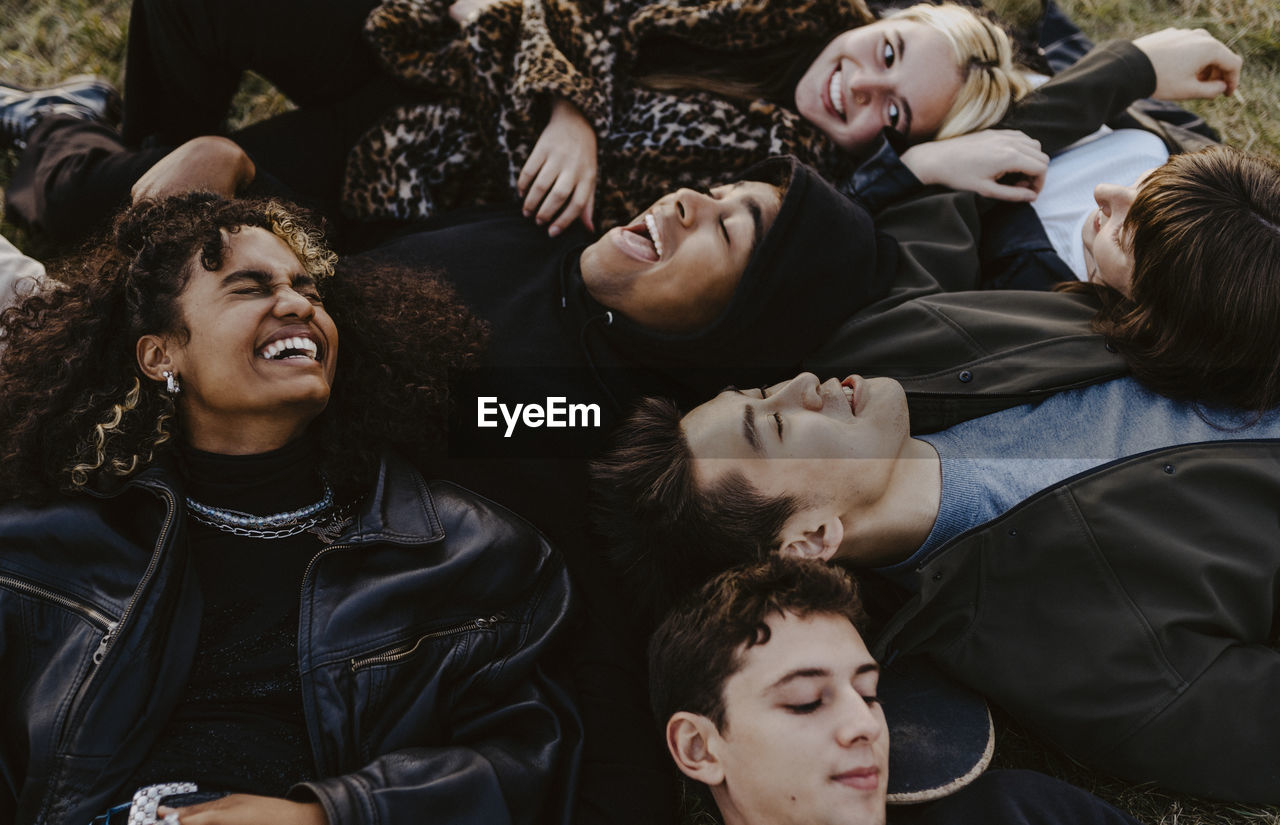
353,160,897,821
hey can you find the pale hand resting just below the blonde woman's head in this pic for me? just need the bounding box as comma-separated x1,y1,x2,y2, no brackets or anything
902,129,1048,201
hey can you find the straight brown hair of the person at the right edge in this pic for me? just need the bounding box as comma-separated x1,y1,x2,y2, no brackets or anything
1094,146,1280,411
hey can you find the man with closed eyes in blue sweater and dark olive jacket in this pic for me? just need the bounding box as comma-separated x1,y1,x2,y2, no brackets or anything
596,350,1280,803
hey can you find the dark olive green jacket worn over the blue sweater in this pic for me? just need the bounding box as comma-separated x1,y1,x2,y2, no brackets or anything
809,292,1280,803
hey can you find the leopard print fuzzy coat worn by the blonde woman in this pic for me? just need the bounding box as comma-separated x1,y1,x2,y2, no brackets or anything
343,0,872,229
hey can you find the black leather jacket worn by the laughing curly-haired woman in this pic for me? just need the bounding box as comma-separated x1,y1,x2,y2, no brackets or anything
0,458,581,825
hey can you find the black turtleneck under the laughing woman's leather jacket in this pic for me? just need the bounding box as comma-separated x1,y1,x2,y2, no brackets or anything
122,439,323,798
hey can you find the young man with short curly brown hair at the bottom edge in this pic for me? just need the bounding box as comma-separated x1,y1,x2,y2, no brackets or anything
649,556,1133,825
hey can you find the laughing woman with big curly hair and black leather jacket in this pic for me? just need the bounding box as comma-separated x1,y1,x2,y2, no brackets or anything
0,194,580,825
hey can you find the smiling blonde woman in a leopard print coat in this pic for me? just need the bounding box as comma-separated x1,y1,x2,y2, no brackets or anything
344,0,1047,234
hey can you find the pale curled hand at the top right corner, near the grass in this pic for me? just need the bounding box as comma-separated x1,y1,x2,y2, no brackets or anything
1133,28,1244,100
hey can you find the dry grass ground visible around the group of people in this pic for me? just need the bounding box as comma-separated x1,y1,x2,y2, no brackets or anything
0,0,1280,825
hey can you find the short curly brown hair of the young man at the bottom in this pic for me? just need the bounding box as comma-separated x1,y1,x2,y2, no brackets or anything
649,554,867,729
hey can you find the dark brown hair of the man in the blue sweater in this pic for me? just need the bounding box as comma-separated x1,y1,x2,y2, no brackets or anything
591,398,800,622
